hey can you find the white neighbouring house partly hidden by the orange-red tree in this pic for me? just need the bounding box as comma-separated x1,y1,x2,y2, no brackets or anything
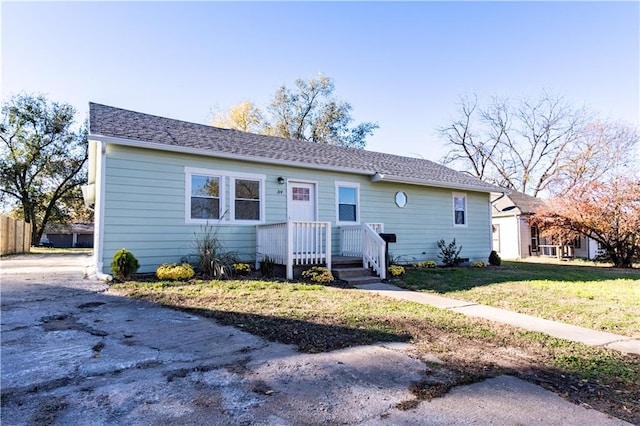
491,191,600,259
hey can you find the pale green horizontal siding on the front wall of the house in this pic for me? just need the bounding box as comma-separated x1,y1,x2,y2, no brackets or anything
102,145,491,273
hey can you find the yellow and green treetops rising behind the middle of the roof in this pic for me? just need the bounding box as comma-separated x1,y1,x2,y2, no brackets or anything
213,74,378,148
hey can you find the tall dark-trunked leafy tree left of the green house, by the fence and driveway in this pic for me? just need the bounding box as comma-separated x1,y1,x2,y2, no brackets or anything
0,94,87,242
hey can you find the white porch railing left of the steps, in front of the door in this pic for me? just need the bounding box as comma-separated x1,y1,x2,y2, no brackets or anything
256,221,331,280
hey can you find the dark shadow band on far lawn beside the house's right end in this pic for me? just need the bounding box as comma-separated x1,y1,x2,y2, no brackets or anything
394,262,640,293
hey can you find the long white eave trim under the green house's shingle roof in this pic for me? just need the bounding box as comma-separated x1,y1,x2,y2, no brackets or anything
89,134,503,194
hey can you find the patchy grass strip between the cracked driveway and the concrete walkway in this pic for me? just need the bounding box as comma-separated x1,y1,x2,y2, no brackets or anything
109,280,640,422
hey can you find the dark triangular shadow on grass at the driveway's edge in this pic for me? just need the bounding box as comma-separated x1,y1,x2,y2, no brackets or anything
178,306,412,353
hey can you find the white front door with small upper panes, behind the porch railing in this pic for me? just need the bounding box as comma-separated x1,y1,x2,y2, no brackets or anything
287,181,319,255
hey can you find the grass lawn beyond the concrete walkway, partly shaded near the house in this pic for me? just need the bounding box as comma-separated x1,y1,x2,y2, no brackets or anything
394,262,640,338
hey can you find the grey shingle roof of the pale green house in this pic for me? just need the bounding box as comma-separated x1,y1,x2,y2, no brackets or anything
89,103,502,192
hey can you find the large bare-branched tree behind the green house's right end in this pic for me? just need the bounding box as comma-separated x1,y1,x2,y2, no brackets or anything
440,93,638,196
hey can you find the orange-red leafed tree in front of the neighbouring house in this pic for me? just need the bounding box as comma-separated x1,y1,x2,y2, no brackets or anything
531,176,640,268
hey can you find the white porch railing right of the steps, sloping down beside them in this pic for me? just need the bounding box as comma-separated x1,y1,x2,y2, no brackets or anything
340,223,387,280
